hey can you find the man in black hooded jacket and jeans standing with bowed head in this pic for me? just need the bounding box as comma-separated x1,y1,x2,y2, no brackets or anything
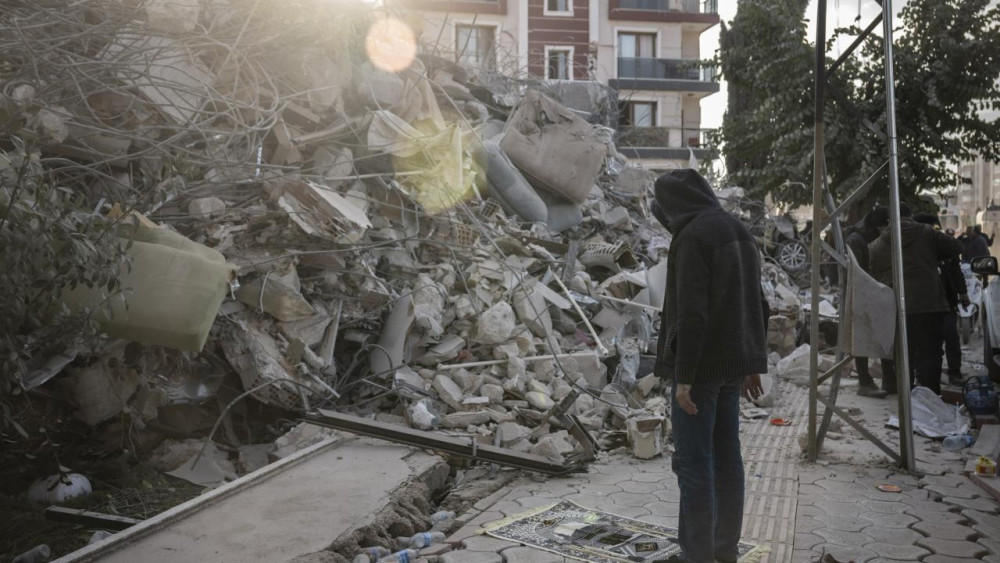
650,169,769,563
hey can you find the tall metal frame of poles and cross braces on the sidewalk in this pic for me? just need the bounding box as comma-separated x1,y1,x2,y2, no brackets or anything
807,0,916,472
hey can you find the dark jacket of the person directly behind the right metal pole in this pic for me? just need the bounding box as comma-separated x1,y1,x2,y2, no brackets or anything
869,218,962,315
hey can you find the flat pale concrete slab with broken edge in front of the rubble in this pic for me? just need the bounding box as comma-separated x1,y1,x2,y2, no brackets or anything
59,439,444,563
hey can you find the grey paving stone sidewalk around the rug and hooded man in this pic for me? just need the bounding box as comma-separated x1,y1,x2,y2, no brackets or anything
443,386,1000,563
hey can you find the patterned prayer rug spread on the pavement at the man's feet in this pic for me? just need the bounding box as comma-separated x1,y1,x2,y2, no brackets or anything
484,500,770,563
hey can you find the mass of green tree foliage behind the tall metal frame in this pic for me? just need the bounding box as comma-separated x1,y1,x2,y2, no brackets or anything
718,0,1000,209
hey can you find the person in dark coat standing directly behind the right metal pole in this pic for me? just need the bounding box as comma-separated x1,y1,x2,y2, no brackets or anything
869,204,962,394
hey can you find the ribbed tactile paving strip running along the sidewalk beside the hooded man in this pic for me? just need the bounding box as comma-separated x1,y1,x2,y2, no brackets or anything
741,382,808,563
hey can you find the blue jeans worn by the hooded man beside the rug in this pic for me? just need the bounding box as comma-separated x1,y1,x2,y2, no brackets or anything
670,382,744,563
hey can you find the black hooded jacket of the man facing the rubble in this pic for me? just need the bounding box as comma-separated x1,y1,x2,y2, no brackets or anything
651,169,770,384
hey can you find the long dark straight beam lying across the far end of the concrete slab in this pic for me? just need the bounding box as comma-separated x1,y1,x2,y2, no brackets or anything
305,409,584,475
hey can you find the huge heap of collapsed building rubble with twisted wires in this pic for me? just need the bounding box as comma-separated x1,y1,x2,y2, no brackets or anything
0,0,992,558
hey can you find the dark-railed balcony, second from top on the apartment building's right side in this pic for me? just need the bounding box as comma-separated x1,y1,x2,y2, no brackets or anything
608,58,719,94
